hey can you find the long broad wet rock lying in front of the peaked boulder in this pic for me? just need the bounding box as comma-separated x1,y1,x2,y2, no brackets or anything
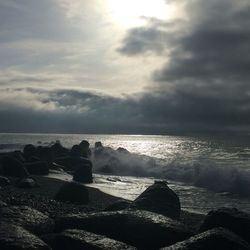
56,210,192,249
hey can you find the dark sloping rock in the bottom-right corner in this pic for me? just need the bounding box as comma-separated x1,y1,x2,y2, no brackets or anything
161,228,250,250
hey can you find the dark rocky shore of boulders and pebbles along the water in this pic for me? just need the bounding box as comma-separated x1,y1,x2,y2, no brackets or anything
0,141,250,250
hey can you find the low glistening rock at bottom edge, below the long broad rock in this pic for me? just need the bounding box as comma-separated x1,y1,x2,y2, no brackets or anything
45,229,135,250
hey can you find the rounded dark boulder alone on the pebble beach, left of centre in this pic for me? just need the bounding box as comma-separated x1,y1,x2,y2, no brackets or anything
55,182,89,204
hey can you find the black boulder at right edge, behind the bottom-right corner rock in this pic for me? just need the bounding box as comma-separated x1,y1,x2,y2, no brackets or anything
200,208,250,243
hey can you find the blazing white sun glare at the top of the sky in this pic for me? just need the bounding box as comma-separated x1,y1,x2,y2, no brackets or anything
108,0,168,27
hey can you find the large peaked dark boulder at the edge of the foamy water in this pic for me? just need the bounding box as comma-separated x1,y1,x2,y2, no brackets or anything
131,181,181,219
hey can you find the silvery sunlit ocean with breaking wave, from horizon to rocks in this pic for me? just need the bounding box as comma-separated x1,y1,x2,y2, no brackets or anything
0,134,250,213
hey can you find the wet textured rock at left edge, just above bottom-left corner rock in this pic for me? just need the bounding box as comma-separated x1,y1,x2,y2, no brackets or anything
0,206,54,235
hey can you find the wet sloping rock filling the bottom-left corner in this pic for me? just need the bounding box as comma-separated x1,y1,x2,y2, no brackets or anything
0,222,51,250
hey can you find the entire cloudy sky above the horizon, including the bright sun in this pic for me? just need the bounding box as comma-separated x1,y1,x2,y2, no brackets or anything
0,0,250,135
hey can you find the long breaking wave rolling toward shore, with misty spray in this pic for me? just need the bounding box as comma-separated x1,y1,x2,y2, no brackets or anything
93,148,250,197
